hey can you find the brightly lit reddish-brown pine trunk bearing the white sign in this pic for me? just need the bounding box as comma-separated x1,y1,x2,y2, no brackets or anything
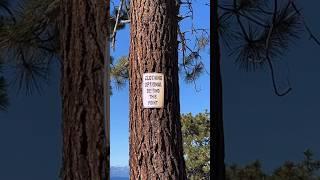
129,0,186,180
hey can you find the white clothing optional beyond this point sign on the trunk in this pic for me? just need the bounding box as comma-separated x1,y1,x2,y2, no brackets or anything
142,73,164,108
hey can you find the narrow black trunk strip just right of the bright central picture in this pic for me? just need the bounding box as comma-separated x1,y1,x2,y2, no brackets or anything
211,1,225,180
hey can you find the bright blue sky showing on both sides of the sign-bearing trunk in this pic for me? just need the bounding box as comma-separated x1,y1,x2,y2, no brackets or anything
110,1,210,166
